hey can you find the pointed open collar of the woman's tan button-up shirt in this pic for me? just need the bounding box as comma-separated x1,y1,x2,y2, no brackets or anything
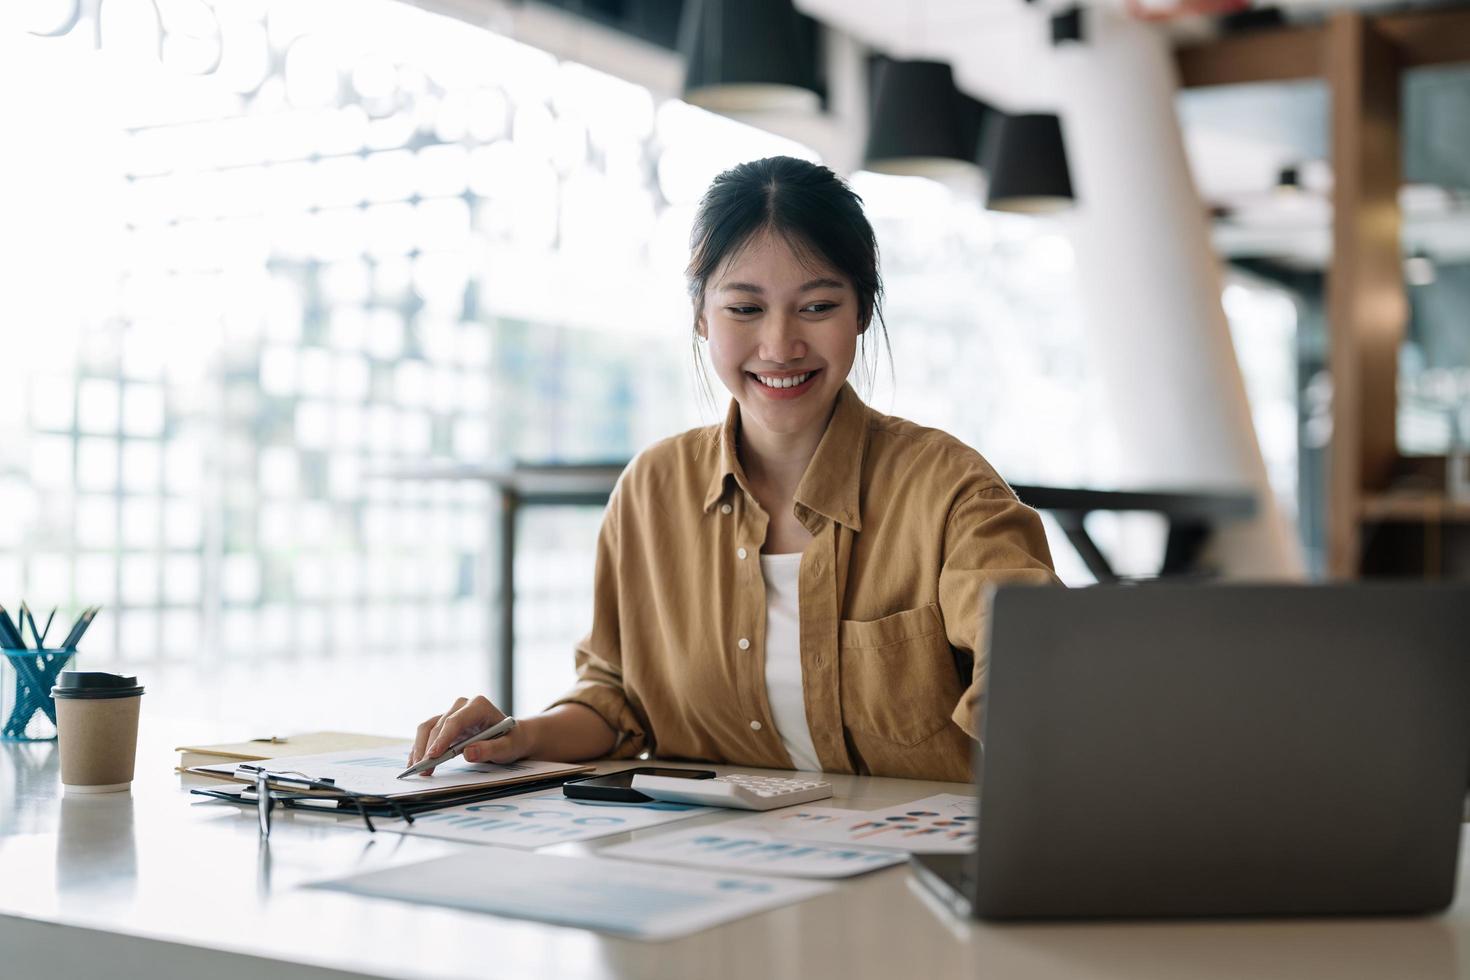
704,383,872,530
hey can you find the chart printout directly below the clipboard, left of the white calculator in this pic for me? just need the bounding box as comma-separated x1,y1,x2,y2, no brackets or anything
378,790,714,848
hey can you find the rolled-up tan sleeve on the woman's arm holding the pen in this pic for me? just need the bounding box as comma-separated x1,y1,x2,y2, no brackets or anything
550,486,648,758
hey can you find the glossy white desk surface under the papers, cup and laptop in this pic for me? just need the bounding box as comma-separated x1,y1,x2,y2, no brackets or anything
0,724,1470,980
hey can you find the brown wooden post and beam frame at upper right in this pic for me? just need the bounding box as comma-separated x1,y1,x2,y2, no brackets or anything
1175,7,1470,579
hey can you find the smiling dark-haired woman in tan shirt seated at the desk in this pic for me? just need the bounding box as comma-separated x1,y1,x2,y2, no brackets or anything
409,157,1055,780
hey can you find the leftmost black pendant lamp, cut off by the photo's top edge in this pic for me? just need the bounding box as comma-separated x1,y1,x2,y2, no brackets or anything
679,0,822,113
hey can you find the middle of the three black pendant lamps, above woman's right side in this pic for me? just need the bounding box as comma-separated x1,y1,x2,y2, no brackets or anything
863,57,989,181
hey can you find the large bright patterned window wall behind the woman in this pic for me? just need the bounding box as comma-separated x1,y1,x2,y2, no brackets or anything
0,0,1105,707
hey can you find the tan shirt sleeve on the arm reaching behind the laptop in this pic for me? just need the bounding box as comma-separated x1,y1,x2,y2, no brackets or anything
939,485,1060,739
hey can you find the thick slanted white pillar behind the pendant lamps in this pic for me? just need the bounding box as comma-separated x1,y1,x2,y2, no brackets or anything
1048,6,1304,579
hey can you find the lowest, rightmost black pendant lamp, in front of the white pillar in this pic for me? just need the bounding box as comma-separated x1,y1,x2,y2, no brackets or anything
983,113,1075,215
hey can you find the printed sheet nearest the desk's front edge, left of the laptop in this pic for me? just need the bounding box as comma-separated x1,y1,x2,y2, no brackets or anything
307,848,832,940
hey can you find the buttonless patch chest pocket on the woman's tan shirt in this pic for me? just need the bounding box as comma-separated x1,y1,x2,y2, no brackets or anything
838,602,964,745
